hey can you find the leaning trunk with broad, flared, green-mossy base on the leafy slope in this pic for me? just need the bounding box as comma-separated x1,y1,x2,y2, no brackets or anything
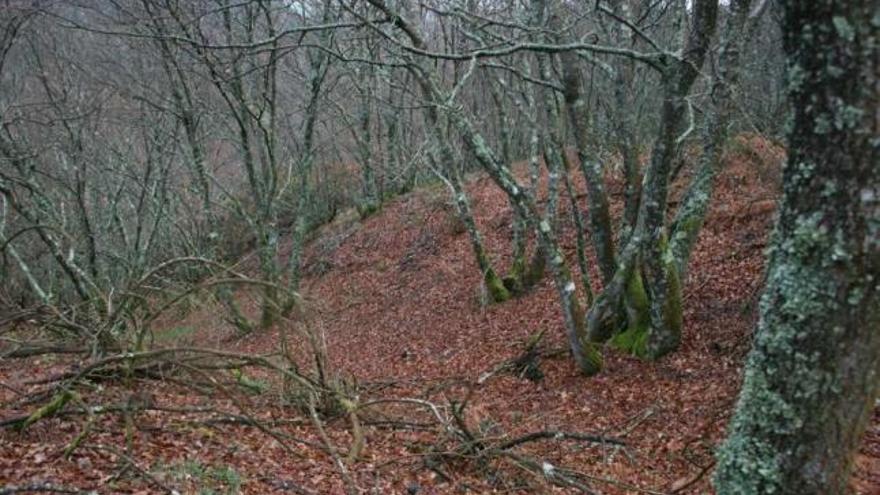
587,0,718,359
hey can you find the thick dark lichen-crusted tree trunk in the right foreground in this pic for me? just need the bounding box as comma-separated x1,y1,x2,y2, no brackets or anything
715,0,880,495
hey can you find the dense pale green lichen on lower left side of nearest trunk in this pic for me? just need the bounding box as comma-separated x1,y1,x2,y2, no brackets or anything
715,211,860,495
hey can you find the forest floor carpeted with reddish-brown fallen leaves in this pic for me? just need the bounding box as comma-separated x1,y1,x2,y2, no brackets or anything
0,136,880,494
